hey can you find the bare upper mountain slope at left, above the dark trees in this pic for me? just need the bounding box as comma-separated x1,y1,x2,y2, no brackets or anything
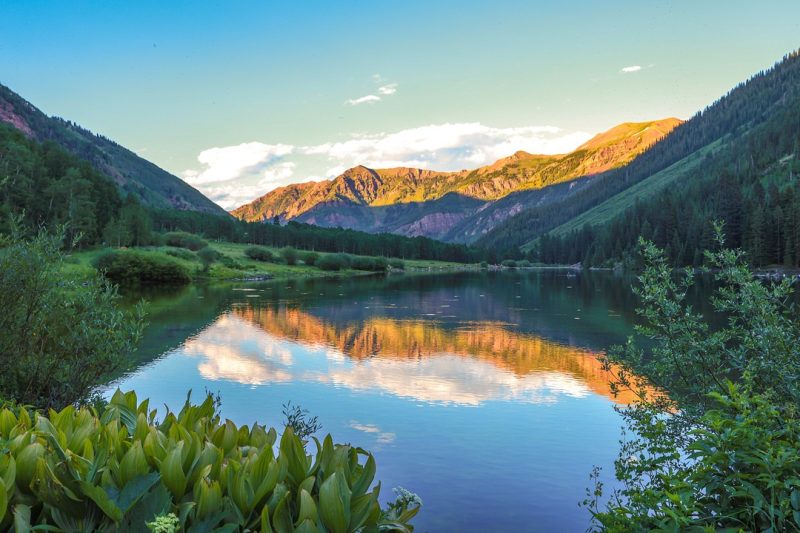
0,85,225,214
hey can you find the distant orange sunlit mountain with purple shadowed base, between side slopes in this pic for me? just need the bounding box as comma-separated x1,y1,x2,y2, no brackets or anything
232,118,682,242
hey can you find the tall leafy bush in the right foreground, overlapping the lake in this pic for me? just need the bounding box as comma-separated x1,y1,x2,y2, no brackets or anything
585,230,800,532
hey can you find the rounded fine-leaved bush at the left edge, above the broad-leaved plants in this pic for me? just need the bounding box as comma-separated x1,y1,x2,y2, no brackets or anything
0,229,142,408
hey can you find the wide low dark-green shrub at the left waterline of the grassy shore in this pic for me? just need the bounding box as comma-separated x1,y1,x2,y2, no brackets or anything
94,250,192,285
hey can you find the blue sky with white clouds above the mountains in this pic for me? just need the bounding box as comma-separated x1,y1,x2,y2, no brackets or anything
0,0,800,207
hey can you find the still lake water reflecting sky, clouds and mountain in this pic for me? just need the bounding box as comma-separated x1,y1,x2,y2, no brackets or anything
109,271,664,532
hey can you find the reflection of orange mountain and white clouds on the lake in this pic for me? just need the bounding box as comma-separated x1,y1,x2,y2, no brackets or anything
177,304,630,405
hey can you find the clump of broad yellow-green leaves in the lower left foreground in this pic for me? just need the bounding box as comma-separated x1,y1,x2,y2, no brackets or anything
0,391,420,532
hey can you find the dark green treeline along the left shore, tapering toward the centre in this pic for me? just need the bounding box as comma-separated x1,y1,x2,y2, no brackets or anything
0,124,490,262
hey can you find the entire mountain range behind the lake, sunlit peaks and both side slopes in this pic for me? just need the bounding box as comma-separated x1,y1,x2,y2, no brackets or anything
0,47,800,265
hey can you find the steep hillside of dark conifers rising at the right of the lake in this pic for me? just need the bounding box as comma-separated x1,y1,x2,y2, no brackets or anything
532,53,800,267
